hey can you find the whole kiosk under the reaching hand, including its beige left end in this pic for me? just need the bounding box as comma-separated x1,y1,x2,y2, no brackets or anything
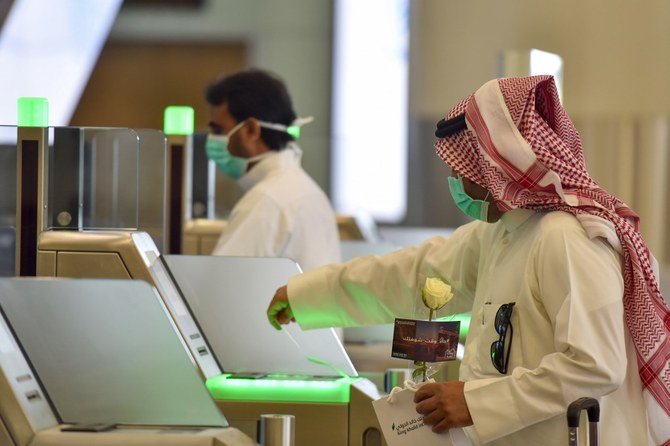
38,231,384,446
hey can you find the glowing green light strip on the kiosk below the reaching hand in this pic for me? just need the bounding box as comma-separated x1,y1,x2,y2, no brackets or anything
205,374,360,403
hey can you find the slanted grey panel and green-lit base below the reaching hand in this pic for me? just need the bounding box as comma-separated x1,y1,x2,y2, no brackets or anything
162,255,385,446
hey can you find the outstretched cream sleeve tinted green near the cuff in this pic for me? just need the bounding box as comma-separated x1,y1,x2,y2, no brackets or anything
288,223,479,329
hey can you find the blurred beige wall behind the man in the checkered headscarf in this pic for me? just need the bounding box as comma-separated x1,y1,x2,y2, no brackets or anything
407,0,670,262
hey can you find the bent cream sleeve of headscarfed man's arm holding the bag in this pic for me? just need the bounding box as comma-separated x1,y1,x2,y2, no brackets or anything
465,231,626,443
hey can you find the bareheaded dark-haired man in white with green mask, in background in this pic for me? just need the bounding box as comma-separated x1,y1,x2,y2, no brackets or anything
206,70,340,271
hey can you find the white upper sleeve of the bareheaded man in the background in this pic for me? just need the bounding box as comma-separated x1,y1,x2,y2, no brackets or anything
212,195,289,257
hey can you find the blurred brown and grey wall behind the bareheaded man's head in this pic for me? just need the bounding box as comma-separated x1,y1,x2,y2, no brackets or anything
73,0,332,197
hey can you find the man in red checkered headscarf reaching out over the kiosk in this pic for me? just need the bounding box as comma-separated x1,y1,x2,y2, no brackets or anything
268,76,670,446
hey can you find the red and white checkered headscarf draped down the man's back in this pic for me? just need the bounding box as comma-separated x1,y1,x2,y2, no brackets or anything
435,76,670,445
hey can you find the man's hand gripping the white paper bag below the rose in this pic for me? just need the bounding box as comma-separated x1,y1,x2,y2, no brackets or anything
414,381,472,433
